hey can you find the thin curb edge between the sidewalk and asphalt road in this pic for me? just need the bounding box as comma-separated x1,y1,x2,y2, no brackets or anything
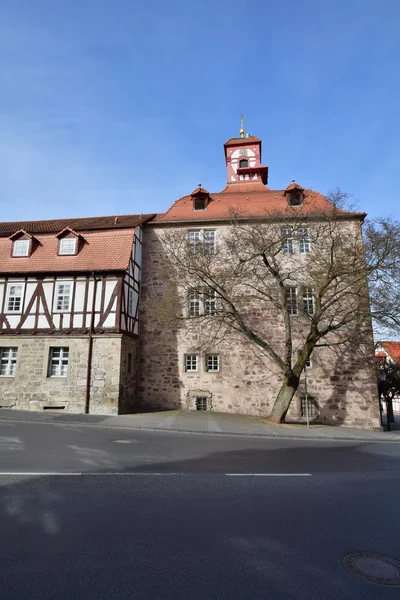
0,415,400,444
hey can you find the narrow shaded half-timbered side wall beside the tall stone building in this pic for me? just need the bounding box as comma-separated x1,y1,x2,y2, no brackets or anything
121,227,143,336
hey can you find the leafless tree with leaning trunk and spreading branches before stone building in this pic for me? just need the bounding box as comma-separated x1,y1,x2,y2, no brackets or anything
151,199,400,422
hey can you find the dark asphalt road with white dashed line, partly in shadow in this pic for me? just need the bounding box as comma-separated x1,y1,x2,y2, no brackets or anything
0,422,400,600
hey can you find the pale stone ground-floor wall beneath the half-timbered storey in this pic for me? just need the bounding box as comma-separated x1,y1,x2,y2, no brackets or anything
0,334,138,415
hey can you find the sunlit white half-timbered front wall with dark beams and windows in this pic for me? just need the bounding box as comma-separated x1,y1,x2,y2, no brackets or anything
0,275,119,334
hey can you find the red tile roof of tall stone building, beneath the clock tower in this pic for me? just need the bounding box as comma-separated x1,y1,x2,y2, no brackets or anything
153,181,365,223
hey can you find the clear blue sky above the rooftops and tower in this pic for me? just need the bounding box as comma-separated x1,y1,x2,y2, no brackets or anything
0,0,400,221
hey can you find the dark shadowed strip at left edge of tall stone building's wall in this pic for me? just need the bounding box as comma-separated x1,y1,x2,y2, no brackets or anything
137,227,181,412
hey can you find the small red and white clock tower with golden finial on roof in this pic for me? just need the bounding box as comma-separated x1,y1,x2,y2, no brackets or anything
224,122,268,185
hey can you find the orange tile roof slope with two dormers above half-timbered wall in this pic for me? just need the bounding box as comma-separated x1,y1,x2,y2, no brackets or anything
0,227,135,275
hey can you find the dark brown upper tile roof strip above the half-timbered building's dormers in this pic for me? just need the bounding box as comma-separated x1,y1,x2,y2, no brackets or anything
0,214,155,236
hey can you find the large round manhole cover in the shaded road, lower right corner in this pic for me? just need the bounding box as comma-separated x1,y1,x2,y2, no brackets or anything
342,552,400,586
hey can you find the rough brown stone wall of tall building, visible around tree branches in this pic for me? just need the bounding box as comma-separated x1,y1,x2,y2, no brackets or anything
139,224,380,428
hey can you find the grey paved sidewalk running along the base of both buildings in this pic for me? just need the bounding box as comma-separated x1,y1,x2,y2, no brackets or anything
0,409,400,442
